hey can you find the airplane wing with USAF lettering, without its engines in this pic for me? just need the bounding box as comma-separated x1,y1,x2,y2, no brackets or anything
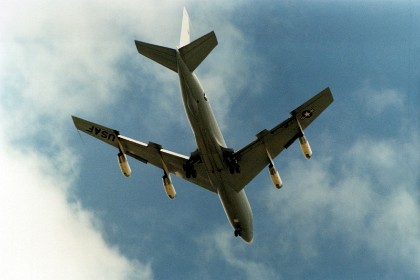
72,116,216,192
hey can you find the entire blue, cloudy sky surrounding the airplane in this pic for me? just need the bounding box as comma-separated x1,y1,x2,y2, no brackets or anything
0,0,420,280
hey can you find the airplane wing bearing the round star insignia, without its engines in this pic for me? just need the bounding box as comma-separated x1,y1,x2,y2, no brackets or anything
234,88,333,191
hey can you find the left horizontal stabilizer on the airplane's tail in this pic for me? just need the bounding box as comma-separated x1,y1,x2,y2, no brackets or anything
135,41,178,72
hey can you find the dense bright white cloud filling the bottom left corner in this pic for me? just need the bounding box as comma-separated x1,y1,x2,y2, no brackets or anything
0,137,152,279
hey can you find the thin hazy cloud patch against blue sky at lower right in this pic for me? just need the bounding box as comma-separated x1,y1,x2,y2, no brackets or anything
264,133,420,275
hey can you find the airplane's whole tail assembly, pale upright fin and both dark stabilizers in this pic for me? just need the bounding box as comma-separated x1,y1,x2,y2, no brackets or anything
135,8,217,72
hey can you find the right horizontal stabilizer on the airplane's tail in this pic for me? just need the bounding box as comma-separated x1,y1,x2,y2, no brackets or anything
179,31,217,72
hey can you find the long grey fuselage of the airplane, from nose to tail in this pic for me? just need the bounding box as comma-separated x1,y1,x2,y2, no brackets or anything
177,49,253,242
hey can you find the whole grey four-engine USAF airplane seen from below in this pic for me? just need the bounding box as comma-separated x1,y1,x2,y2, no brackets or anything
72,8,333,243
